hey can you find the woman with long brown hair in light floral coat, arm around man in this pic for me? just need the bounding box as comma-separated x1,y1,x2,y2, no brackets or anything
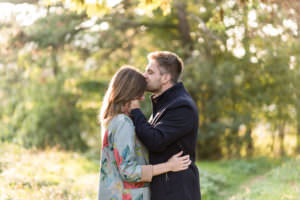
99,66,191,200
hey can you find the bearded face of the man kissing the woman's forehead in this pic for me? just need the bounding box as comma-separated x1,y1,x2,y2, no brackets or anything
144,60,163,93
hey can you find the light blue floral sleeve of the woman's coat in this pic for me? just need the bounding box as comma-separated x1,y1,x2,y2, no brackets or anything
113,116,142,182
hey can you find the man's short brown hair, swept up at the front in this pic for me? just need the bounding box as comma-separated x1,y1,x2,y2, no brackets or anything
148,51,184,83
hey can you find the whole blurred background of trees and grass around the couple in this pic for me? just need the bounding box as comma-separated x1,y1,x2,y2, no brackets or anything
0,0,300,200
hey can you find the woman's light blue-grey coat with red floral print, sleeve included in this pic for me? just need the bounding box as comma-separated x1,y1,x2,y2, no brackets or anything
99,114,150,200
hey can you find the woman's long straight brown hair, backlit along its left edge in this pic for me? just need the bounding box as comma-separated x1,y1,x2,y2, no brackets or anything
100,66,147,127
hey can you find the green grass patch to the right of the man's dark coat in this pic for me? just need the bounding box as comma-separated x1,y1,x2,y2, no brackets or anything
198,158,300,200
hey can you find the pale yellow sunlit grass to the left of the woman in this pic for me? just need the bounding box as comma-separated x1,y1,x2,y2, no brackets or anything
0,144,99,200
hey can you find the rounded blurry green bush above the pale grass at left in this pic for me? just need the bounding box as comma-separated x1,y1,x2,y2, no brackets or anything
6,80,87,151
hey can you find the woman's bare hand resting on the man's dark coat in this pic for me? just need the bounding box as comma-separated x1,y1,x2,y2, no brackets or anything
167,151,192,172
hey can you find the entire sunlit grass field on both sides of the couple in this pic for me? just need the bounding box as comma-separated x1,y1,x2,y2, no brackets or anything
0,143,300,200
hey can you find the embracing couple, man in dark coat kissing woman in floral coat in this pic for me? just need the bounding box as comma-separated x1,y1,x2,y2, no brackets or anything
98,51,201,200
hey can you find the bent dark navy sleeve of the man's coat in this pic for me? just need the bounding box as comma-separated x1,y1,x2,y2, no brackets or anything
131,106,195,152
